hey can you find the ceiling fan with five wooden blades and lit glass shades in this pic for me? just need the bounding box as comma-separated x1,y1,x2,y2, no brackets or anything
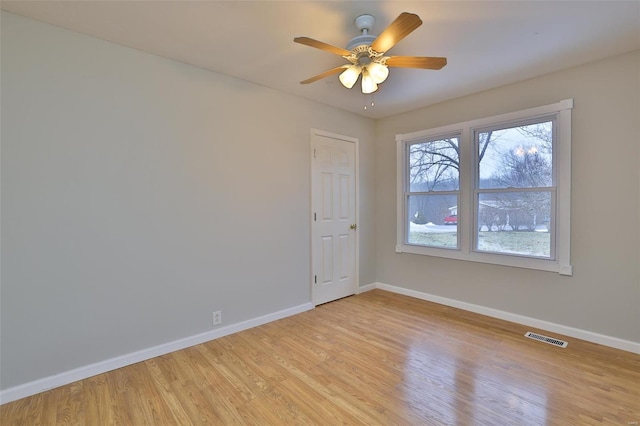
293,12,447,93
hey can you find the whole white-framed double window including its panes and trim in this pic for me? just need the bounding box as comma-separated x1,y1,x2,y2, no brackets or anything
396,100,573,275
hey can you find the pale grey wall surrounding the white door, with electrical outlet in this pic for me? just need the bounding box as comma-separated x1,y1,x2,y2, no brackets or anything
0,12,375,389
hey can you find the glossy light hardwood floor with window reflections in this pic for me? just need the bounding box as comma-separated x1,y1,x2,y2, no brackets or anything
0,290,640,426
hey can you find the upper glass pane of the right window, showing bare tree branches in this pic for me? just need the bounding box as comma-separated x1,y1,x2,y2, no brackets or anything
476,121,553,189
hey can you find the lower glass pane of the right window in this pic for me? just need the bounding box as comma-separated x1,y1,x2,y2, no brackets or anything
476,191,552,258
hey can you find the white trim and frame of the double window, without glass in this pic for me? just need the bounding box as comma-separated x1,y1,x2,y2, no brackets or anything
396,99,573,275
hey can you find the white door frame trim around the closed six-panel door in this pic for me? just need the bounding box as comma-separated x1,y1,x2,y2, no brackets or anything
309,128,360,306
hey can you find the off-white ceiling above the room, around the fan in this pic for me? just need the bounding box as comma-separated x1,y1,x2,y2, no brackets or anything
2,0,640,118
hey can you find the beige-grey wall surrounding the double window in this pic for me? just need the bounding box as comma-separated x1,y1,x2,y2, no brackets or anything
376,52,640,342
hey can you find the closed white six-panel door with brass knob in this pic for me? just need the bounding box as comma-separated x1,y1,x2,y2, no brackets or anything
311,131,357,305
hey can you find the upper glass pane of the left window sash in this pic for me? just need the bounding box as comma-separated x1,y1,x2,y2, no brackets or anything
409,137,460,192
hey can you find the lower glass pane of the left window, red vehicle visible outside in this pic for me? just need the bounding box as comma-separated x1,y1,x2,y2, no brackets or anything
407,195,458,248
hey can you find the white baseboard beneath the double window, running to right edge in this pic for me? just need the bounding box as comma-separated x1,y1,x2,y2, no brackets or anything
370,283,640,354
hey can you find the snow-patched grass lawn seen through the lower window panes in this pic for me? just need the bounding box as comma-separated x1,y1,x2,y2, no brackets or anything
409,231,551,257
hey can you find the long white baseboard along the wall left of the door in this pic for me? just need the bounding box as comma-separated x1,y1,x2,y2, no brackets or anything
0,303,313,405
